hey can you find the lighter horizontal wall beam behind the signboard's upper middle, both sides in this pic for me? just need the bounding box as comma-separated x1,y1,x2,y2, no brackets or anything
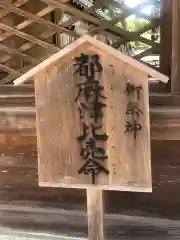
0,103,180,141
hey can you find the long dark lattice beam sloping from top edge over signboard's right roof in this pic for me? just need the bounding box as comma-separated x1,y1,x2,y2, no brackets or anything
42,0,159,46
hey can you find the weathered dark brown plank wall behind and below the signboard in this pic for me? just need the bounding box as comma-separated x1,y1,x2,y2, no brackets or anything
0,86,180,240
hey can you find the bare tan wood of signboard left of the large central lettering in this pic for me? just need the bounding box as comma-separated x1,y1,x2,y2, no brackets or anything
35,62,91,187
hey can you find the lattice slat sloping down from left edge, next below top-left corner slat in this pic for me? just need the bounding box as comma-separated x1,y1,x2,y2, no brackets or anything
0,23,59,53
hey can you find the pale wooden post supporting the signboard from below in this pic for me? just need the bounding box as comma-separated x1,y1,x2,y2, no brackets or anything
87,189,104,240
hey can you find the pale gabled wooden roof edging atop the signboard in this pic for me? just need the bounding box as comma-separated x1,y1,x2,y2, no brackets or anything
14,35,169,85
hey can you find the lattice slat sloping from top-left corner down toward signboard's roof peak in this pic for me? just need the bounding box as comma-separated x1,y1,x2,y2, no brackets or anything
0,0,79,38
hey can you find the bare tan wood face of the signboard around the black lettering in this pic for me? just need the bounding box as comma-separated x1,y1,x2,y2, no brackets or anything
35,51,152,192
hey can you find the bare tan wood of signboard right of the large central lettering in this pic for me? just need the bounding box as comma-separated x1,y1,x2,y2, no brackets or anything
102,55,151,191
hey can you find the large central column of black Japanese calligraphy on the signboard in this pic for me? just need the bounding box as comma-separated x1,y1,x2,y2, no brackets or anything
74,53,109,184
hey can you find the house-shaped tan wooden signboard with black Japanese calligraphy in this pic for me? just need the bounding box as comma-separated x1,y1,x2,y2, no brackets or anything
15,36,168,239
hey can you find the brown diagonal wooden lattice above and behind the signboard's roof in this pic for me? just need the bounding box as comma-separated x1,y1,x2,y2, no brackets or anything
0,0,160,84
